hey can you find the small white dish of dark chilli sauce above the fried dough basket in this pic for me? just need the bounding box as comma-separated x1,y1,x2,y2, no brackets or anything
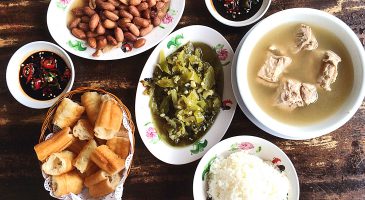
6,41,75,109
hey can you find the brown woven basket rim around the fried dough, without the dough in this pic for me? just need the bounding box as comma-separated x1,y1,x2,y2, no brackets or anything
39,87,135,189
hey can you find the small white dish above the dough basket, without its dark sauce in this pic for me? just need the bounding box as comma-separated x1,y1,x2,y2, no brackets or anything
6,41,75,109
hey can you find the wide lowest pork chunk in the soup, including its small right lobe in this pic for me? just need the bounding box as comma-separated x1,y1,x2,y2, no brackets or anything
276,79,318,111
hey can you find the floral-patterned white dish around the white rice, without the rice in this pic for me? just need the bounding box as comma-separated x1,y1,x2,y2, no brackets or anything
193,136,299,200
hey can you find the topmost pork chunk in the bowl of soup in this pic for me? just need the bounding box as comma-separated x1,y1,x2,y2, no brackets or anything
294,24,318,53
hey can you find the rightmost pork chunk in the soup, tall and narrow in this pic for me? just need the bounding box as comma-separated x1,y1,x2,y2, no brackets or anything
317,51,341,91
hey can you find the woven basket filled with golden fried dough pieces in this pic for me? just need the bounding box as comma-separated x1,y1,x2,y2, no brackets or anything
34,88,135,200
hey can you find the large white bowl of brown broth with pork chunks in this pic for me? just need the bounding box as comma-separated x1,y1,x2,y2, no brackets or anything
235,8,365,140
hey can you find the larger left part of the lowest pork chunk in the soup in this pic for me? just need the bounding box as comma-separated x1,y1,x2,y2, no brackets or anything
276,79,304,111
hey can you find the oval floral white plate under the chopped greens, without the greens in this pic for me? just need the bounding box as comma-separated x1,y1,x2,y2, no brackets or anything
135,26,236,164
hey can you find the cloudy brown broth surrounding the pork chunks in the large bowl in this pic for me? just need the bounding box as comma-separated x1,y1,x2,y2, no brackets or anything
247,23,354,125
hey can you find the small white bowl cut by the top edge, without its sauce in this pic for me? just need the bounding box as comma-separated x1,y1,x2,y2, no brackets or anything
205,0,271,27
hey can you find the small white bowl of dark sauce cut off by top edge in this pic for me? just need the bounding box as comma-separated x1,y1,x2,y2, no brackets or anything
205,0,271,27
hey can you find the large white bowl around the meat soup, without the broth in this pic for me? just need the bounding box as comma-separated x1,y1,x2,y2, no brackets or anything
235,8,365,140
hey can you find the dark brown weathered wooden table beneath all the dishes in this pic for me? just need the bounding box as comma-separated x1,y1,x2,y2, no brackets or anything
0,0,365,200
